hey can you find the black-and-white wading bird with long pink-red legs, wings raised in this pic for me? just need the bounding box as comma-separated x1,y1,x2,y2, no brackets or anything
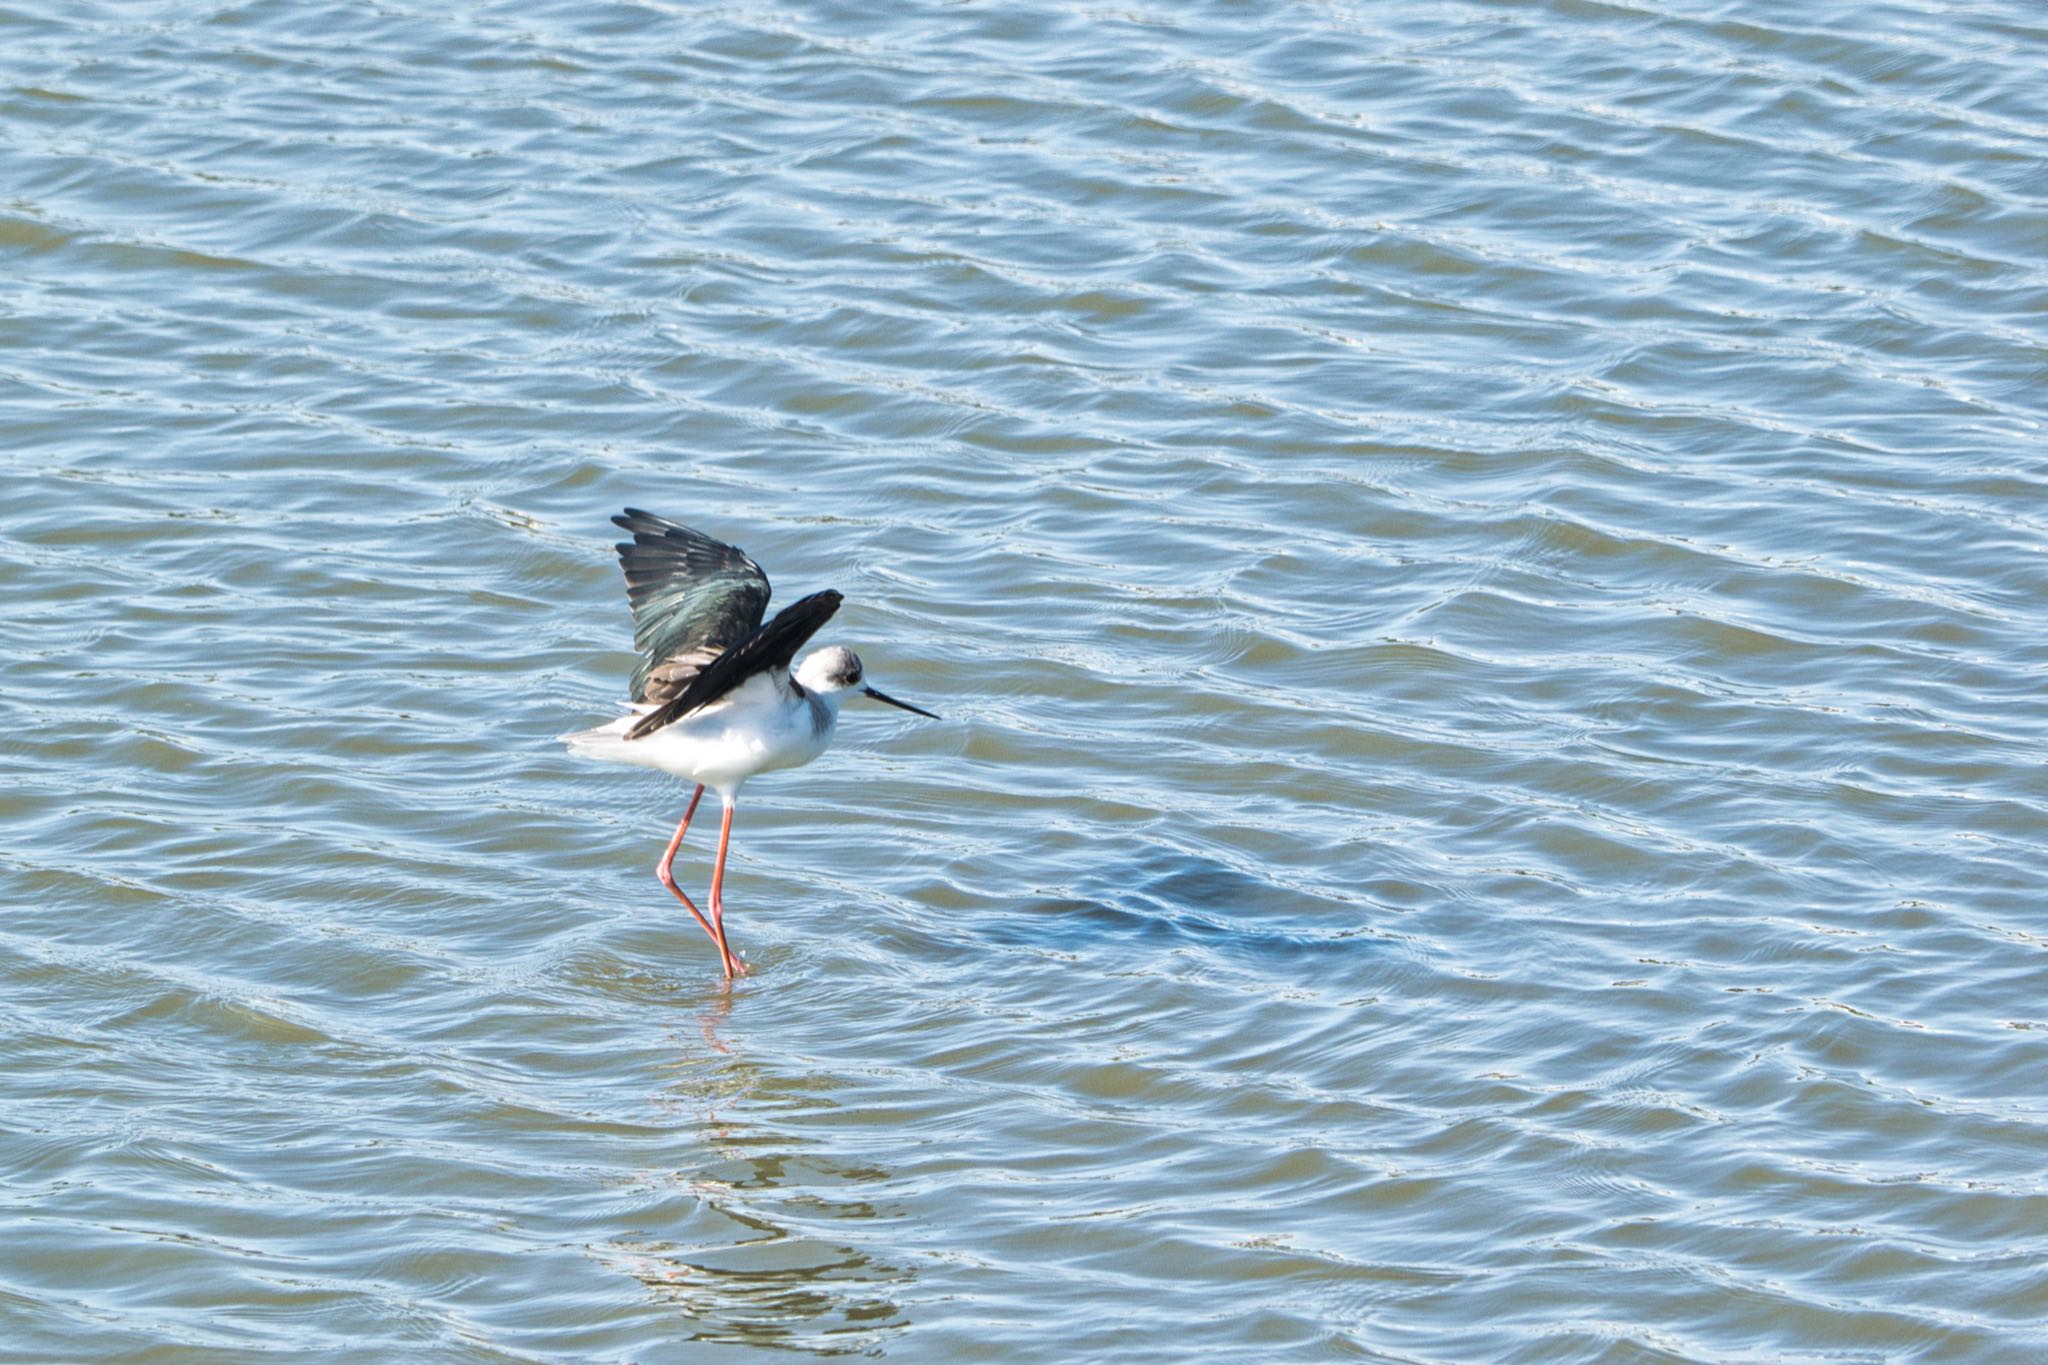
561,508,940,982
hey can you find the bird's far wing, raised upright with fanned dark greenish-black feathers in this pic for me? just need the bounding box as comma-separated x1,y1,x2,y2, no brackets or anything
612,508,768,706
